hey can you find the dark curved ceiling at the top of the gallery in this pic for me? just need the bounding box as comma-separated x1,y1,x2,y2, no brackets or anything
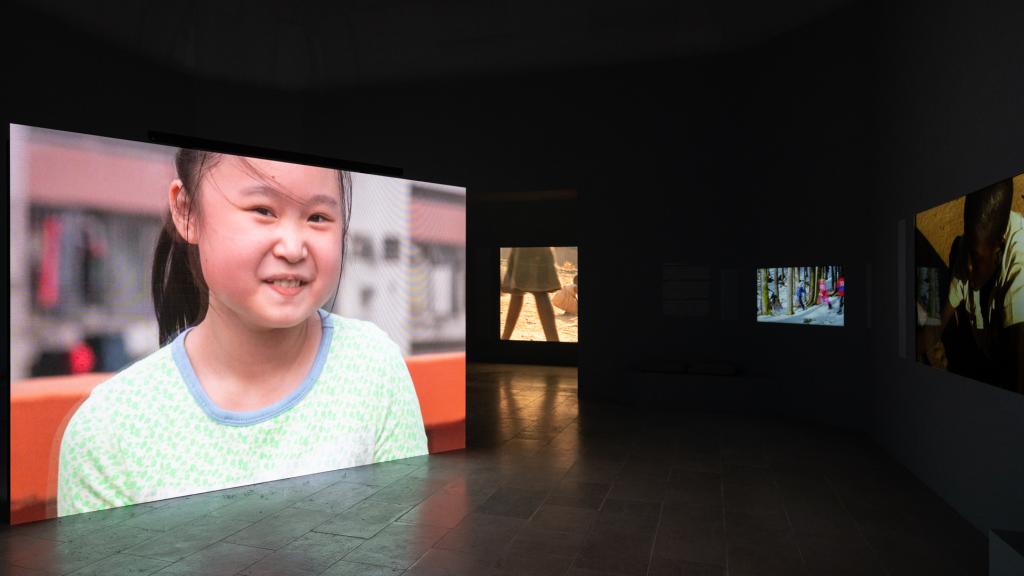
30,0,850,89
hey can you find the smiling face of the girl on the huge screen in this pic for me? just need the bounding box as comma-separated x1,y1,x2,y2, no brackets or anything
172,155,343,328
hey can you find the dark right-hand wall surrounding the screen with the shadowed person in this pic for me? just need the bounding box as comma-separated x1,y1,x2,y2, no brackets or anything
870,1,1024,532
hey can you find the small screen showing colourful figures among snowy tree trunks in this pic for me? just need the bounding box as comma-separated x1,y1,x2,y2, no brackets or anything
755,265,846,326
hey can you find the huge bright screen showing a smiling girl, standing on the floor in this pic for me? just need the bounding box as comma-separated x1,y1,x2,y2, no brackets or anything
9,125,466,524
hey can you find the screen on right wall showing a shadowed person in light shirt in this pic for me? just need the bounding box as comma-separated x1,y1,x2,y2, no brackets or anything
914,174,1024,394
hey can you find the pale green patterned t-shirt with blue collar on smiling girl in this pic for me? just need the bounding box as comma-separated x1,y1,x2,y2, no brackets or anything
57,311,427,516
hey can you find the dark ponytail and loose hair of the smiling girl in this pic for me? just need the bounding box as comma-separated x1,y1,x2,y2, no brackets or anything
153,149,352,346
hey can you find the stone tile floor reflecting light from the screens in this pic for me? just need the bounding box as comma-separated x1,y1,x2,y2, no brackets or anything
0,365,987,576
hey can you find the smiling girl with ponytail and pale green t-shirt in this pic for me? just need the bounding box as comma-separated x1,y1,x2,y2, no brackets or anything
57,150,427,516
